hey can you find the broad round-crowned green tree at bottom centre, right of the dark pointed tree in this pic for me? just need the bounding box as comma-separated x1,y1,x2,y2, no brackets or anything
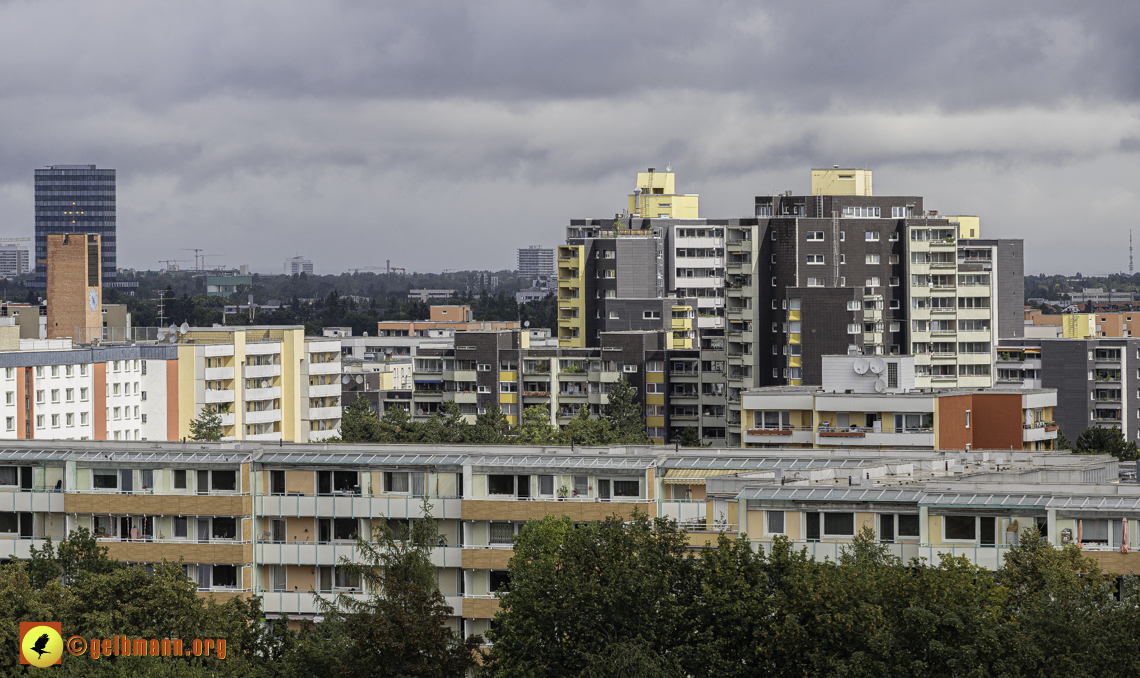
488,512,699,678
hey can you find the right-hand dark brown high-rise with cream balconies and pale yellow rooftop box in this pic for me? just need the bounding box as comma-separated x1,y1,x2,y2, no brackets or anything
756,168,1024,387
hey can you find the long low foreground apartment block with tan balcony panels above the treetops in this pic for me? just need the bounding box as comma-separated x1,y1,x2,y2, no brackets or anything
0,441,1140,634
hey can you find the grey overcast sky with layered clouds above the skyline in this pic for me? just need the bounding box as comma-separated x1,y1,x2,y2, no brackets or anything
0,0,1140,273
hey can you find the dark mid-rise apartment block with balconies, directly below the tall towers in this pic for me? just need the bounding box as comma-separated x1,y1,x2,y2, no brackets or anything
405,330,731,447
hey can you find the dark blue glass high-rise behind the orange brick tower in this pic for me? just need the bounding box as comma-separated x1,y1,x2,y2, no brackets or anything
29,165,117,288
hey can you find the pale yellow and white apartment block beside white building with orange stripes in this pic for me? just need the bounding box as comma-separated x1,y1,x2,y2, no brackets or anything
168,326,342,442
